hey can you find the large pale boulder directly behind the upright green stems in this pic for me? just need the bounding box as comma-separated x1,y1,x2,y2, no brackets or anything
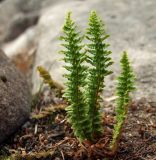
33,0,156,98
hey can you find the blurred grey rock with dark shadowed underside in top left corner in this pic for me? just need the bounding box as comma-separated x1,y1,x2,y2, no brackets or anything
0,0,63,45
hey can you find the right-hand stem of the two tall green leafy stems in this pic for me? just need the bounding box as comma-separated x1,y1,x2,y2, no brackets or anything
86,11,113,137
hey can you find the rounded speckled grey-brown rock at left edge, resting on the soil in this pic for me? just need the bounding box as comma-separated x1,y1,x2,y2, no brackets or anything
0,50,31,143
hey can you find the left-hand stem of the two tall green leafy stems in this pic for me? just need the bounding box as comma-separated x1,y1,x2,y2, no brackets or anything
60,12,91,141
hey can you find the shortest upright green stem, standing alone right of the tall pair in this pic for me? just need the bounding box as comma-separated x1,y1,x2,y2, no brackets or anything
111,52,135,152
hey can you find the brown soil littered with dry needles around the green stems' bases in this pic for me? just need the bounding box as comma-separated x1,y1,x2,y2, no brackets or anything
0,90,156,160
